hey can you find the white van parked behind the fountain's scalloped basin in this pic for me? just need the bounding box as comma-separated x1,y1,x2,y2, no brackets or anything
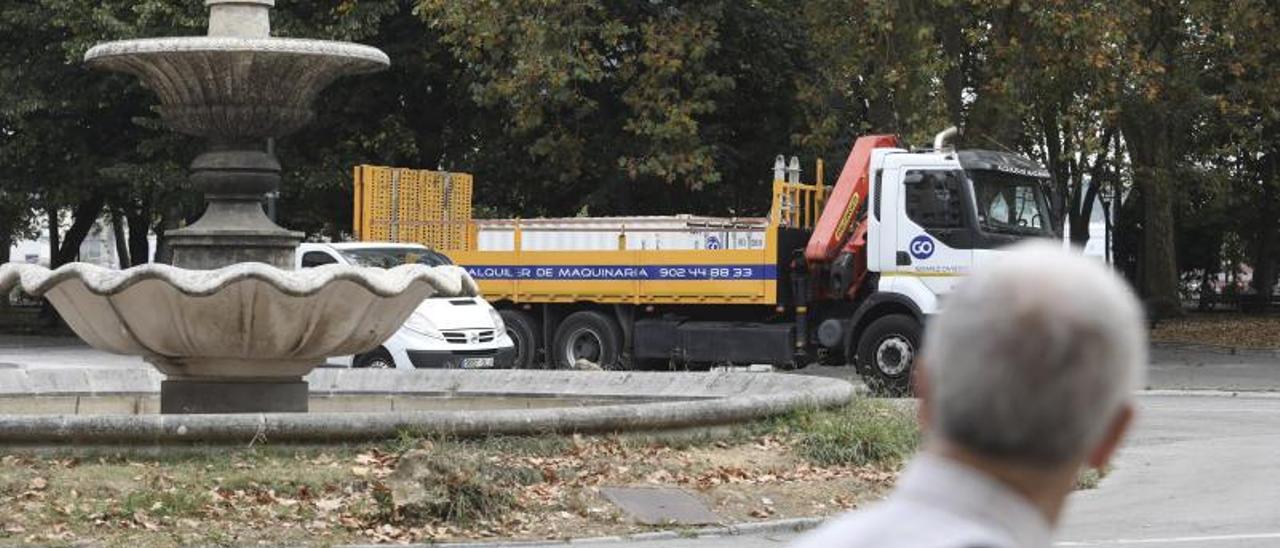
297,242,516,369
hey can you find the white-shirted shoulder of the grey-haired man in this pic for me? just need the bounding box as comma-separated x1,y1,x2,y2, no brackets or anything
791,502,1014,548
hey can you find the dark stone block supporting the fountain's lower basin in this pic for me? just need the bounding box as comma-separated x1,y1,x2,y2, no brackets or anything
160,378,310,415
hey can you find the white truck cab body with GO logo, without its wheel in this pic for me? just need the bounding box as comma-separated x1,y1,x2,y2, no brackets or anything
867,149,1055,315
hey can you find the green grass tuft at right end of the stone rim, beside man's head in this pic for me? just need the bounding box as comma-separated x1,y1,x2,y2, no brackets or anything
782,398,920,466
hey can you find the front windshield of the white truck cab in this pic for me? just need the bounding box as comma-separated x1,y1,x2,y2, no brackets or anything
968,170,1053,236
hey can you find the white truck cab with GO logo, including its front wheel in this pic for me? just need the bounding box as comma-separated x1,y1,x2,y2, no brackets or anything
845,141,1060,393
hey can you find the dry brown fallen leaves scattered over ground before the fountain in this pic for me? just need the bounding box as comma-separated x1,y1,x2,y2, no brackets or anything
0,435,895,545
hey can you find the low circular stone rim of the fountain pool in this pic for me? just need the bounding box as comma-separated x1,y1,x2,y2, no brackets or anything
0,369,855,444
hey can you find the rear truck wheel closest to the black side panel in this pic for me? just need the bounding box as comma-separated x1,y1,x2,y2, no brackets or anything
547,310,623,370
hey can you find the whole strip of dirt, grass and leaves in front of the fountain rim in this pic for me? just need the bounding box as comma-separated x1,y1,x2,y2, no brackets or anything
0,402,918,547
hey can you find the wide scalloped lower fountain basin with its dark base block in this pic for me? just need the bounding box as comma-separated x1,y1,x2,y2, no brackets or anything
0,264,477,414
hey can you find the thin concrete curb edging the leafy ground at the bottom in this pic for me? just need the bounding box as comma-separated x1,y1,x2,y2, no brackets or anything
346,517,827,548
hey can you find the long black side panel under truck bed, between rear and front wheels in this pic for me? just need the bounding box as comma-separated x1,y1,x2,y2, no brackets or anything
634,319,795,366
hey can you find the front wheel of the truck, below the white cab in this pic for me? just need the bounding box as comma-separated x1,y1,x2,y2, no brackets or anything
858,314,920,396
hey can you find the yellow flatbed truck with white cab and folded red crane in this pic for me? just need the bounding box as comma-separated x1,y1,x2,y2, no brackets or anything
414,128,1057,393
